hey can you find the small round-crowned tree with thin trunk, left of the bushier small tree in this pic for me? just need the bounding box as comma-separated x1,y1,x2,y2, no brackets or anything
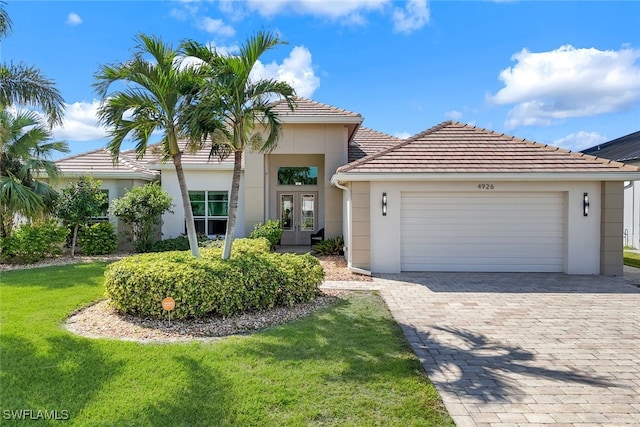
56,176,107,257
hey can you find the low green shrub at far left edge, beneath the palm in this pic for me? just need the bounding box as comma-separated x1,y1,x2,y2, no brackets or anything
0,221,68,264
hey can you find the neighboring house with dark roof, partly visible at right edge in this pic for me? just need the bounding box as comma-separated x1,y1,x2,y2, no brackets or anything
583,131,640,249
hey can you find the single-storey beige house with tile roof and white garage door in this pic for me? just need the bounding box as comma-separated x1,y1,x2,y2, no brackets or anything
58,98,640,275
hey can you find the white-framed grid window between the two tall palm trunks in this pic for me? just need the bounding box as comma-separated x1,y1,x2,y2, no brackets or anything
185,191,229,236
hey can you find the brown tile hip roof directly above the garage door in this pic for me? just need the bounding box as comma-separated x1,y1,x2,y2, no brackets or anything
338,121,639,173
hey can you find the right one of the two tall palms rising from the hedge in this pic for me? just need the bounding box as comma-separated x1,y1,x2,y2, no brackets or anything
182,31,295,259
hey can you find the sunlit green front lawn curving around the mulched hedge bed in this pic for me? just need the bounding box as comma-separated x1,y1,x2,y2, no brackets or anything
0,263,453,426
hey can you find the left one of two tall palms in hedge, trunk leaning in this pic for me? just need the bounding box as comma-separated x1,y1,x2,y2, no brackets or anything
94,34,208,257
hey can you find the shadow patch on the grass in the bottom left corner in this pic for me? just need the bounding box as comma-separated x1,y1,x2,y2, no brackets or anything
0,334,123,425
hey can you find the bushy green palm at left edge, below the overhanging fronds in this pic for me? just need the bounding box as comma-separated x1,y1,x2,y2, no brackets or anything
0,110,69,237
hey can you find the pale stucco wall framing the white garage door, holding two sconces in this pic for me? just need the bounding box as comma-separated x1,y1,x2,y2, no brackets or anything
369,181,601,274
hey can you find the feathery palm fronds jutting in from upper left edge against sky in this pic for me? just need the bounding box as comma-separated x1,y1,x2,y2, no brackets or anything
0,2,64,127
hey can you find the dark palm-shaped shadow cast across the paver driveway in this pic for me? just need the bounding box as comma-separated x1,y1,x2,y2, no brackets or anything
402,325,617,403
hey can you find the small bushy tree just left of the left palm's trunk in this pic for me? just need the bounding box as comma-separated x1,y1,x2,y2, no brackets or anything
111,182,173,252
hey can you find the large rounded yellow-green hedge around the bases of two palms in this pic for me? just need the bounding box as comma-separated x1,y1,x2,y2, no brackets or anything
105,238,324,319
